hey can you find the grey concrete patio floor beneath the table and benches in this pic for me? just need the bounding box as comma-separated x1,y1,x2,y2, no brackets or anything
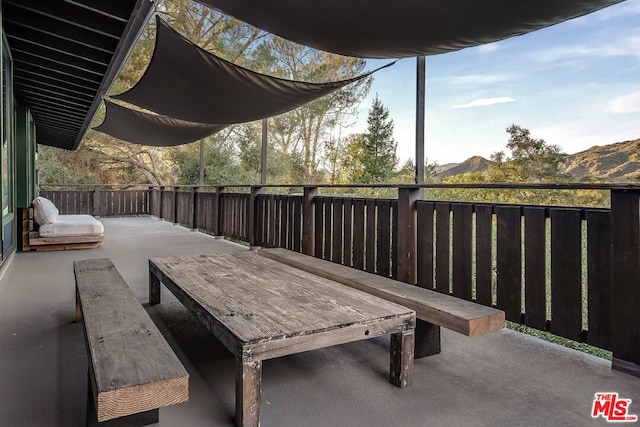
0,218,640,427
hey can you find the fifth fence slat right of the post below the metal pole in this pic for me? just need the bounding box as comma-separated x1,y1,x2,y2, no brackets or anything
496,206,522,323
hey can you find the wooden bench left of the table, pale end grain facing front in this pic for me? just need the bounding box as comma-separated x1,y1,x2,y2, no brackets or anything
73,258,189,426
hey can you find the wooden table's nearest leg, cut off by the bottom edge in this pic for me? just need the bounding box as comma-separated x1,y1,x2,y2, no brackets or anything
236,359,262,427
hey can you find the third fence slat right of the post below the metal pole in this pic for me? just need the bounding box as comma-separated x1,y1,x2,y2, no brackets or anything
451,203,473,301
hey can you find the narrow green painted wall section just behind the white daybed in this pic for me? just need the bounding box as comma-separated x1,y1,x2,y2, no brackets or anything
15,105,36,208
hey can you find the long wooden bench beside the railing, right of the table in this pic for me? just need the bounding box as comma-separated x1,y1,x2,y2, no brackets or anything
258,248,505,358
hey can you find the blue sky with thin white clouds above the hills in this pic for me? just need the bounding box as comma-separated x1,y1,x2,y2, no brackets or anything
350,0,640,164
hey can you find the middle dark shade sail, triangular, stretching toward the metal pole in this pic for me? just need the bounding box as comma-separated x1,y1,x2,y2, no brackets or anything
113,18,391,124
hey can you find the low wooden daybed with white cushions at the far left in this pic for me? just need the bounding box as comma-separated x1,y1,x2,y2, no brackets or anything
29,197,104,250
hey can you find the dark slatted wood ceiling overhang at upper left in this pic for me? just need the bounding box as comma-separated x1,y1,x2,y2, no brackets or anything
2,0,154,149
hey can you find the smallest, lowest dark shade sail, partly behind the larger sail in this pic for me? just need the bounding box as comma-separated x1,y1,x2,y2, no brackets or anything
94,100,227,147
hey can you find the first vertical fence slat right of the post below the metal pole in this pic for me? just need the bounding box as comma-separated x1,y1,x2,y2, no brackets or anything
416,200,435,289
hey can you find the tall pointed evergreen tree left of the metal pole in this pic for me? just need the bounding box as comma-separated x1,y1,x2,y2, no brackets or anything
353,95,398,184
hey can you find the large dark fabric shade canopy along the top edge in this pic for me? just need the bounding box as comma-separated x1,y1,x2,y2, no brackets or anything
196,0,623,58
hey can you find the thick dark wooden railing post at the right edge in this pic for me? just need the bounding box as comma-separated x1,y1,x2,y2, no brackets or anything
611,190,640,376
